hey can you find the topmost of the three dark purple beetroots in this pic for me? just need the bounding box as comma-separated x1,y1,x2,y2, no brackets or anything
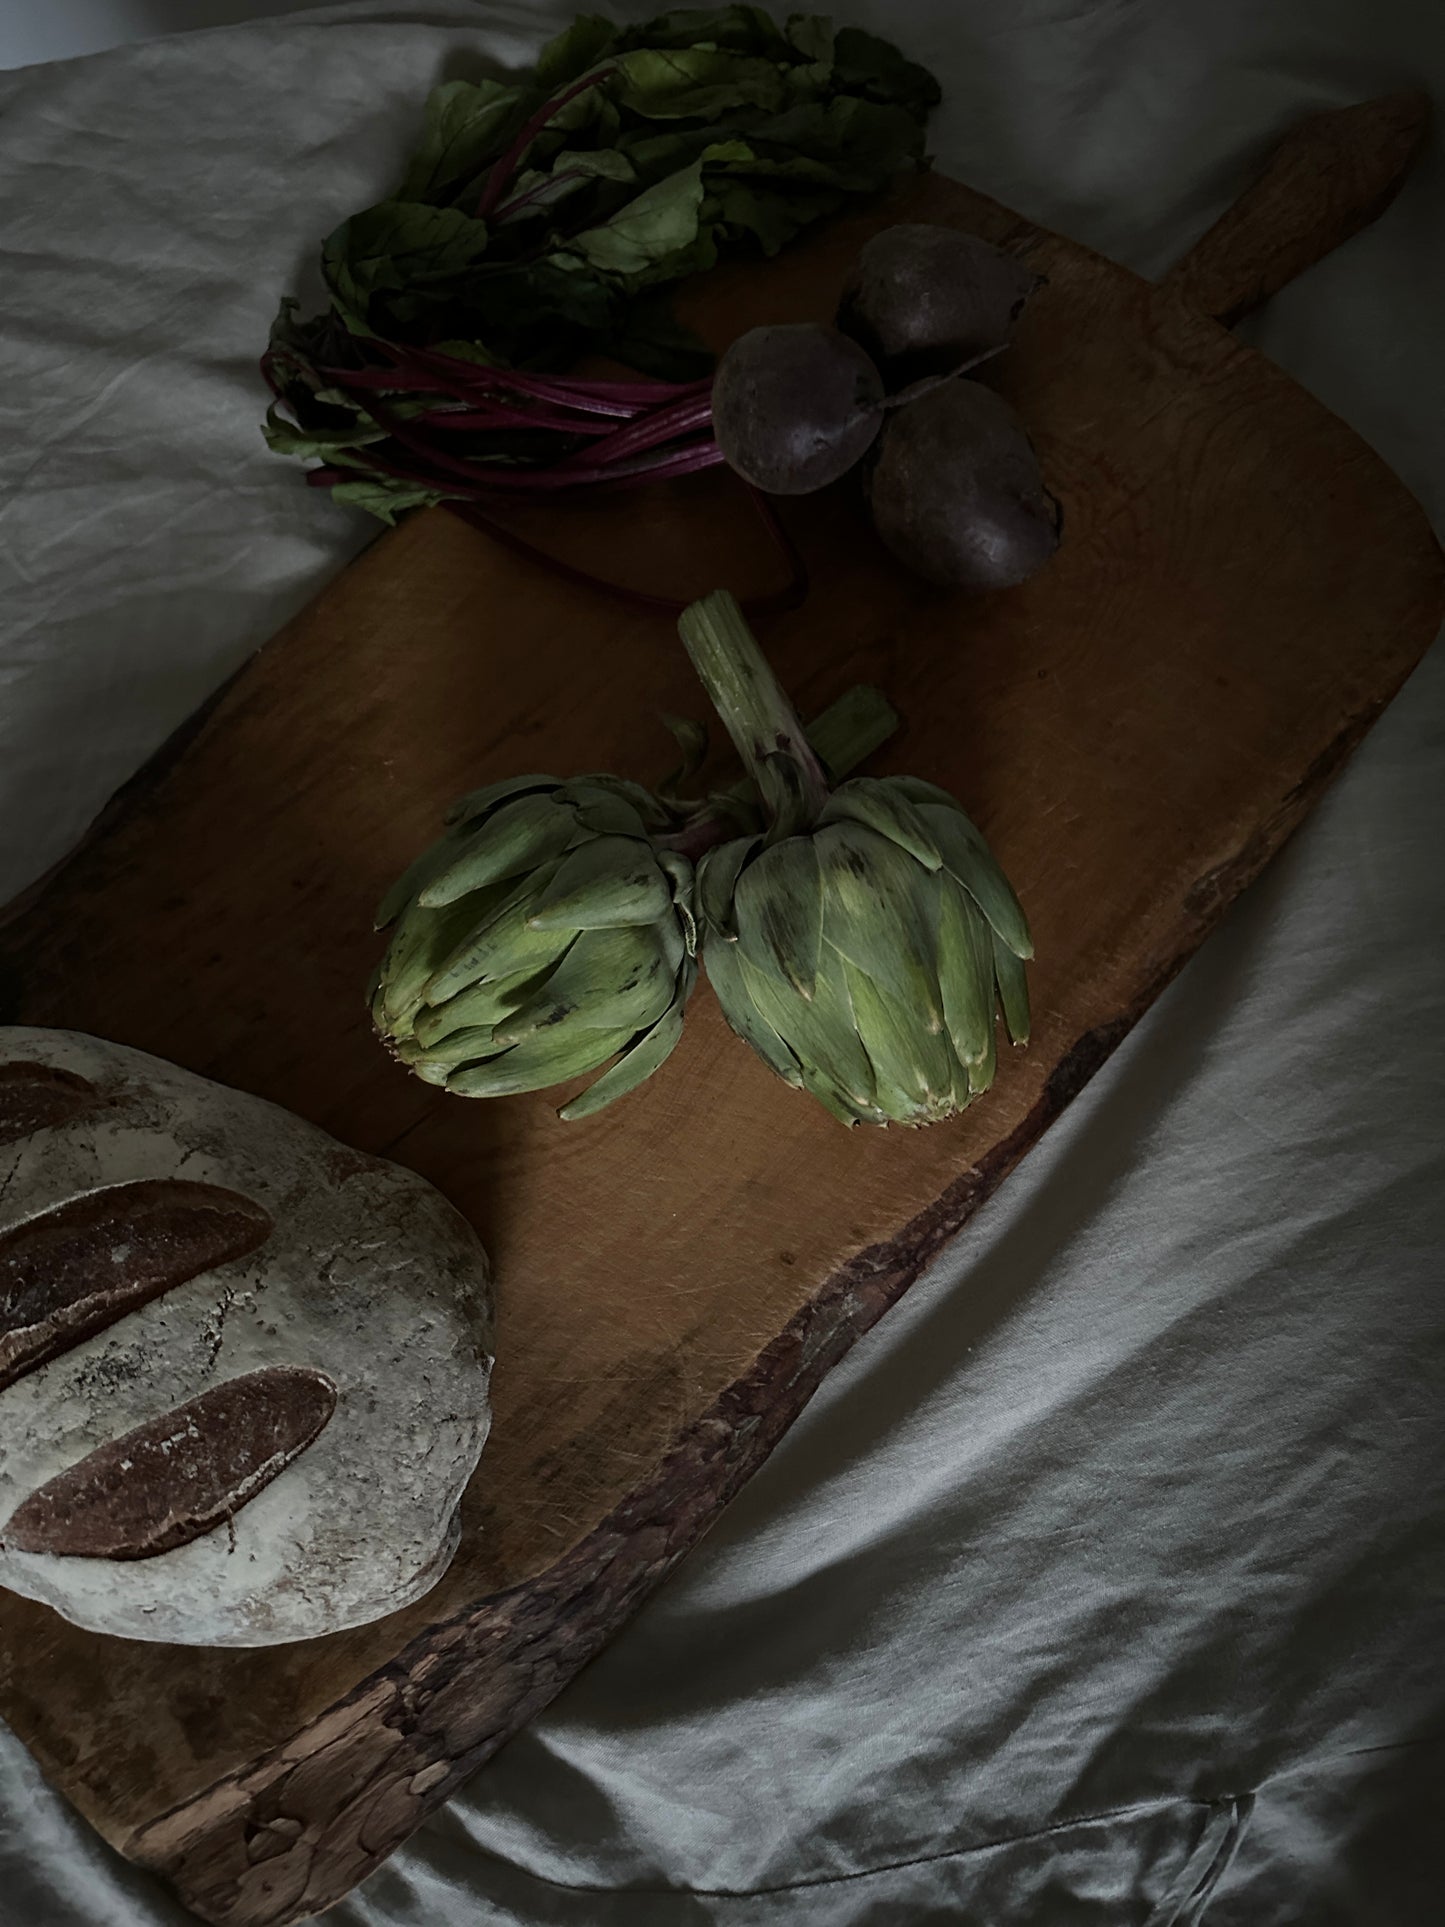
838,222,1040,393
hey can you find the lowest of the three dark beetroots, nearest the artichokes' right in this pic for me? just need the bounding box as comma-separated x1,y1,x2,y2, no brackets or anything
865,380,1060,590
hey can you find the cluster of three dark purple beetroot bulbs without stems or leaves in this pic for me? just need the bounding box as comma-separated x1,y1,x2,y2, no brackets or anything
713,224,1060,590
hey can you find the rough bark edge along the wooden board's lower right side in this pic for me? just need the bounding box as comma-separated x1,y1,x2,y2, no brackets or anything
123,647,1441,1927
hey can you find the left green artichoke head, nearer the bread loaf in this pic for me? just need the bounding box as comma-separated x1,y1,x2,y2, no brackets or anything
372,777,697,1118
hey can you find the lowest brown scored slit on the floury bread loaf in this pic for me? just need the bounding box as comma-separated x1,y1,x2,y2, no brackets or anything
0,1364,337,1559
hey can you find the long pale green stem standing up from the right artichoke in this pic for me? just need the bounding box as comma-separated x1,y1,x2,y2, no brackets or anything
678,590,828,834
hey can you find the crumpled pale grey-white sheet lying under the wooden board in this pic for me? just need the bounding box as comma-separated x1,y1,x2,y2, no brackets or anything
0,0,1445,1927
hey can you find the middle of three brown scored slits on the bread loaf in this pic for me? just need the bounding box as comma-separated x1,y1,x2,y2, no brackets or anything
0,1177,272,1389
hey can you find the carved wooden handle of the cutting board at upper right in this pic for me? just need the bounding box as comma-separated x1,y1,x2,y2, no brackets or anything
1160,92,1430,328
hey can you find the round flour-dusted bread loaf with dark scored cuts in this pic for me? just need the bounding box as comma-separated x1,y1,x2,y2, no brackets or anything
0,1029,491,1646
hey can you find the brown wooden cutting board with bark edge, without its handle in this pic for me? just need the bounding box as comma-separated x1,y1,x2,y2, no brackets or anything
0,101,1445,1927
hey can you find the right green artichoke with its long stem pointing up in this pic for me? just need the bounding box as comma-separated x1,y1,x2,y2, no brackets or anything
678,592,1033,1125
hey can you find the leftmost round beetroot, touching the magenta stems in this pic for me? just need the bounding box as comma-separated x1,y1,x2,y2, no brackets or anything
713,322,882,495
